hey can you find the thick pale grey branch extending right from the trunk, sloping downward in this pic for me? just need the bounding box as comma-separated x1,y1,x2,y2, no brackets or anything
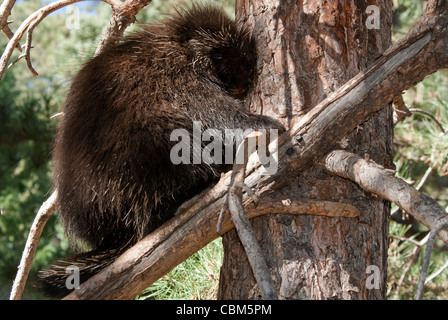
325,150,448,244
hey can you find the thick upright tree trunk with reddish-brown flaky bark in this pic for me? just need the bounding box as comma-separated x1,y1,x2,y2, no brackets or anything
218,0,393,299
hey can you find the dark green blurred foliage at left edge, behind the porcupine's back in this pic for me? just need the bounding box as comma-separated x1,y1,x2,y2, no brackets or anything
0,67,63,297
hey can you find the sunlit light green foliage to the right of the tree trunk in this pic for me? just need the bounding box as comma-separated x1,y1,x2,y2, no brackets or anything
388,0,448,300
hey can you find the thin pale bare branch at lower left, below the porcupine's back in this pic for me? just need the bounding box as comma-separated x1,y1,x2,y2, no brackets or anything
10,192,57,300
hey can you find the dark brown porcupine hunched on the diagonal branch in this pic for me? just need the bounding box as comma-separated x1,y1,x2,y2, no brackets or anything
37,5,282,297
